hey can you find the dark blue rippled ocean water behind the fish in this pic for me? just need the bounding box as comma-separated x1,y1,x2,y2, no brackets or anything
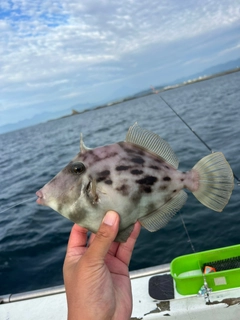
0,72,240,294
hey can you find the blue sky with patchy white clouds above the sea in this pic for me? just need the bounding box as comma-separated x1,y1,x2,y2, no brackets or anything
0,0,240,126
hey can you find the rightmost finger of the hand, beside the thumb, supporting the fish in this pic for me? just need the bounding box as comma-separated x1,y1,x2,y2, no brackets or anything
116,222,141,266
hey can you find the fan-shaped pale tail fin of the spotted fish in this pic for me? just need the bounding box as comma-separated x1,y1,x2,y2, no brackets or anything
191,152,234,212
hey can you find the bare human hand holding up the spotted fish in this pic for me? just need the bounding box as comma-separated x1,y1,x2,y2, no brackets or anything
63,211,141,320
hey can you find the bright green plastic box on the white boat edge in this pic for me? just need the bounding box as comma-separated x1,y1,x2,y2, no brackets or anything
170,245,240,295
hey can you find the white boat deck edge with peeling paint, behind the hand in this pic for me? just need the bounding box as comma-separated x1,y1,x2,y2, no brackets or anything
0,264,240,320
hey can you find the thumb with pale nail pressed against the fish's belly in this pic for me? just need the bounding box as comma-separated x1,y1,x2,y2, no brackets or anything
86,211,120,260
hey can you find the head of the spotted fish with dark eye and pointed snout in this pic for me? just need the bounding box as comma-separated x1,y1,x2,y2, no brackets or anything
36,138,102,227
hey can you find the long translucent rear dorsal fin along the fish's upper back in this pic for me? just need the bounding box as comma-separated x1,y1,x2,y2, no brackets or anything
126,122,179,169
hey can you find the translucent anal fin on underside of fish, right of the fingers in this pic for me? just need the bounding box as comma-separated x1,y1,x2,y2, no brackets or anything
139,190,187,232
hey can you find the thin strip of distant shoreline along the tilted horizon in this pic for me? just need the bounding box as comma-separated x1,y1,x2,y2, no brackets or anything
47,67,240,122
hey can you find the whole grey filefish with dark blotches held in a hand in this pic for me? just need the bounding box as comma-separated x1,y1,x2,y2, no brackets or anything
36,123,234,242
